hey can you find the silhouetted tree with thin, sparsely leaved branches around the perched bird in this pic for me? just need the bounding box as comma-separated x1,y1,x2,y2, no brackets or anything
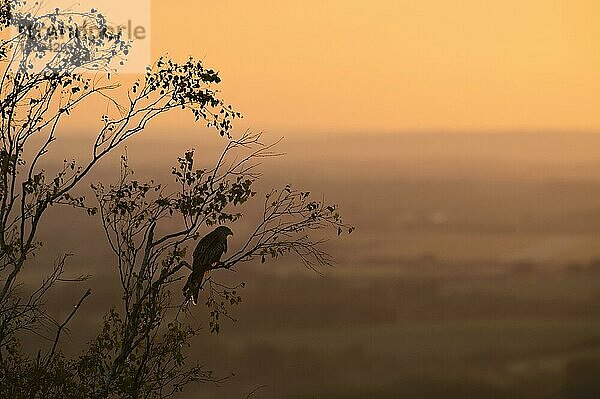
0,0,352,398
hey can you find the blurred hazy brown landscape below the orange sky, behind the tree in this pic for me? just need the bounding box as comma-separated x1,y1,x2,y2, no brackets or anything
31,131,600,399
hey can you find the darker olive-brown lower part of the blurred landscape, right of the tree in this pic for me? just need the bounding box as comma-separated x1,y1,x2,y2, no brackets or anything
190,262,600,399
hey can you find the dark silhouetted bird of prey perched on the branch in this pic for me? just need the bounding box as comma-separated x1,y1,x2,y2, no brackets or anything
183,226,233,305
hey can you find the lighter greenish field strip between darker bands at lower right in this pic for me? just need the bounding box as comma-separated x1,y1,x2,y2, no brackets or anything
228,318,600,361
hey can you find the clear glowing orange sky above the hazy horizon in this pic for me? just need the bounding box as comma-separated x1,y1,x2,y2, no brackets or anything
52,0,600,133
